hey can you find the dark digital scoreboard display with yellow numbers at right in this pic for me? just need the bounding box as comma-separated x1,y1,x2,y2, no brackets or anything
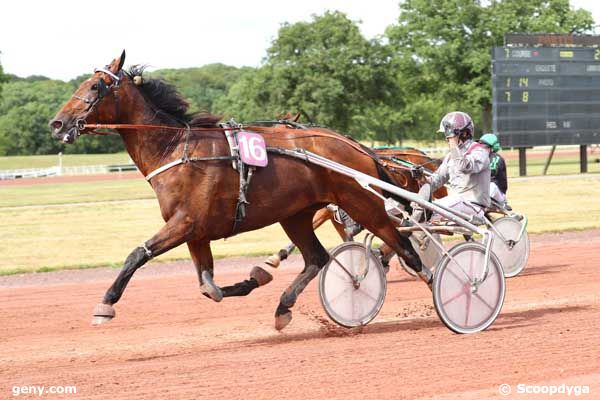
492,47,600,147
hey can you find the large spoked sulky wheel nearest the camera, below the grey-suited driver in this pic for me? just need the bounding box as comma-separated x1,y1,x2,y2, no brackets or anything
432,242,506,333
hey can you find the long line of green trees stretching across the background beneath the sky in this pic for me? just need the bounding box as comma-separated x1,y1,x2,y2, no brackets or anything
0,0,594,155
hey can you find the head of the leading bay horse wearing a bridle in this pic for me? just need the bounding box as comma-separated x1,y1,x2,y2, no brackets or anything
49,50,131,143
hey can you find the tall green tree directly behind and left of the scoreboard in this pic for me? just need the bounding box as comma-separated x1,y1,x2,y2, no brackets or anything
386,0,594,136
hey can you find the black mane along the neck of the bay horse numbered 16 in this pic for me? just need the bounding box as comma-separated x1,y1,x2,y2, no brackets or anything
127,65,221,128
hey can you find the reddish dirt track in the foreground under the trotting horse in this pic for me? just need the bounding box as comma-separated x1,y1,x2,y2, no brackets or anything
0,231,600,399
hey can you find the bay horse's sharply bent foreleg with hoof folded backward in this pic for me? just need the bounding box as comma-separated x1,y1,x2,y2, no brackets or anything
188,241,273,302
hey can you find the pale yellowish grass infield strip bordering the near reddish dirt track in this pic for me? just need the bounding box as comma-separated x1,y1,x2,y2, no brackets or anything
0,175,600,274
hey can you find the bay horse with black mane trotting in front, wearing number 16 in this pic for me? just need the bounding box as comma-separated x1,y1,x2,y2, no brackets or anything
50,51,432,330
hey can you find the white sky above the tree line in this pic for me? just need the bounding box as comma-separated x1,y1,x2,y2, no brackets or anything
0,0,600,80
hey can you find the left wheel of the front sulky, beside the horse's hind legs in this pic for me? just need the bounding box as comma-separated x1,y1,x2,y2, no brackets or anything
319,242,387,328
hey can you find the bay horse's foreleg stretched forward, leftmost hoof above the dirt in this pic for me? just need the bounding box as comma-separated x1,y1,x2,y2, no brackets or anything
92,214,193,325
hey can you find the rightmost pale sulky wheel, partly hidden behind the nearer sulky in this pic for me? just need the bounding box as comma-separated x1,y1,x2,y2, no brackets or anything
491,217,529,278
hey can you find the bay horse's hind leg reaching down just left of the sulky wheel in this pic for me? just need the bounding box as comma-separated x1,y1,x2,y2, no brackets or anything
275,209,330,330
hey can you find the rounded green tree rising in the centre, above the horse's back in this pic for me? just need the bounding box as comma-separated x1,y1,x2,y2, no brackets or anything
218,12,395,139
